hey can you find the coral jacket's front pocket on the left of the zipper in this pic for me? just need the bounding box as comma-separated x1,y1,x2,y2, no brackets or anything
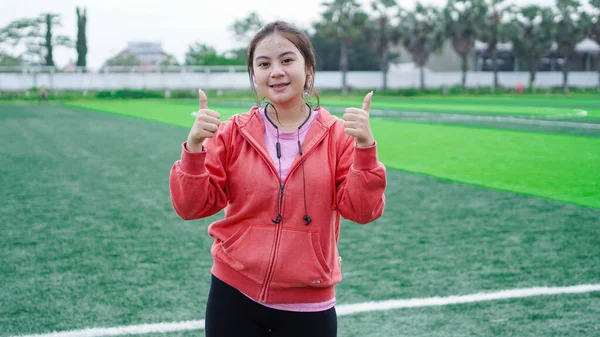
213,224,275,284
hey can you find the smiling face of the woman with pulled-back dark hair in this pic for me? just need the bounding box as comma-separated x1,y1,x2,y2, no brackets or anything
252,33,311,105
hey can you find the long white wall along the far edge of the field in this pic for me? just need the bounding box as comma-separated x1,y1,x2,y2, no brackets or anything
0,71,600,91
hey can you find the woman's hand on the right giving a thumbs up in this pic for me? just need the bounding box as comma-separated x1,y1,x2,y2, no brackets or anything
344,91,375,147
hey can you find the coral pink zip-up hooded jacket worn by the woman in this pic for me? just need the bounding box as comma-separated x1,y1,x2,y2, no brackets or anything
170,107,386,303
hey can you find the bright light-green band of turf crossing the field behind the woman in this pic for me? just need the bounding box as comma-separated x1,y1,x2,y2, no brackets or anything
65,98,600,208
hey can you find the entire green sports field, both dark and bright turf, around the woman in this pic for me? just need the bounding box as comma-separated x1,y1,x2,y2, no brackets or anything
0,97,600,337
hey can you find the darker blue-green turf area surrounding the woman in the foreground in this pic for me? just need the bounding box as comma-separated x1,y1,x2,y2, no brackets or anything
0,105,600,337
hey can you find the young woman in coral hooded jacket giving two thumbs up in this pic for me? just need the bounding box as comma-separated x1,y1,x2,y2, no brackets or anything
170,21,386,337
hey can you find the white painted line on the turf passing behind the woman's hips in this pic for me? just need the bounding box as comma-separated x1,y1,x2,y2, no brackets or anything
12,284,600,337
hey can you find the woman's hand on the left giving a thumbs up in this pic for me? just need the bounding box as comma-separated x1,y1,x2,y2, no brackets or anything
186,90,221,152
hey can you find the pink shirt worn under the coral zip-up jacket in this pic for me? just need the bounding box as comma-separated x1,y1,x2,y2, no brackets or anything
247,109,336,312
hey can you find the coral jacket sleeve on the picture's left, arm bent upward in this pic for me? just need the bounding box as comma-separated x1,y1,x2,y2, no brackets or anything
169,121,232,220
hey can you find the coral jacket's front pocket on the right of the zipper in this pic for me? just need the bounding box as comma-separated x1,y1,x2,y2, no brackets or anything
271,228,332,288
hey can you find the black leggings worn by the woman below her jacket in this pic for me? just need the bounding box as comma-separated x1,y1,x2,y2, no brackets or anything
205,276,337,337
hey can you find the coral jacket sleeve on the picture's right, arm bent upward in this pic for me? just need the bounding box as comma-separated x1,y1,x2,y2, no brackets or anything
335,133,387,224
